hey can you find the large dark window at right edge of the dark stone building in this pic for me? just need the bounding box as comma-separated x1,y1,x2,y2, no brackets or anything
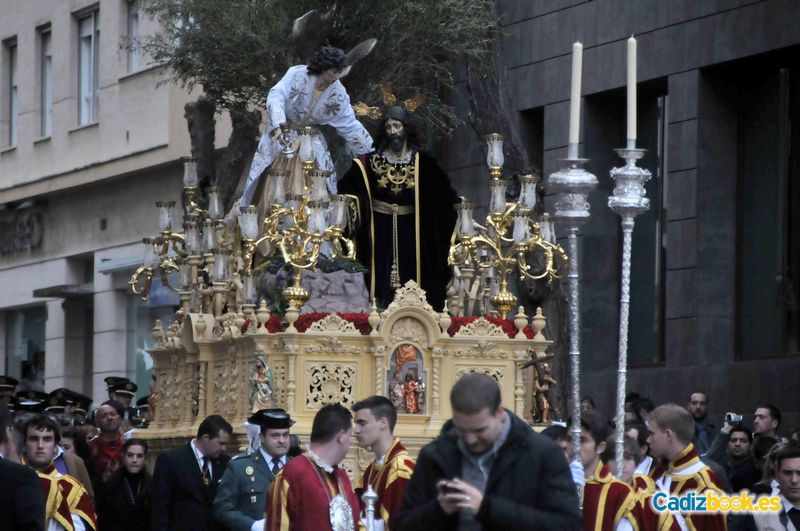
737,65,800,359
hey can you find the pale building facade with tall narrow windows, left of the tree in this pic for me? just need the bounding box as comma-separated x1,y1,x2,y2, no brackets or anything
0,0,230,405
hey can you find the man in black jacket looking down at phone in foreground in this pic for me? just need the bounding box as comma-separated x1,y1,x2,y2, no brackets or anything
391,373,583,531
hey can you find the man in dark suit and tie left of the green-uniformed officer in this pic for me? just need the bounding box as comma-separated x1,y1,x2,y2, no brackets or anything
152,415,233,531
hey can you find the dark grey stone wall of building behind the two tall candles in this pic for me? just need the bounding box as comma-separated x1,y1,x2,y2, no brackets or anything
448,0,800,428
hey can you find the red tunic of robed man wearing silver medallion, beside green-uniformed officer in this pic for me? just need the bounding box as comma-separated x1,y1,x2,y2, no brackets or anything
265,455,359,531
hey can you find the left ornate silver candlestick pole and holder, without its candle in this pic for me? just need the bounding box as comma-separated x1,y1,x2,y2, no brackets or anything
547,144,597,462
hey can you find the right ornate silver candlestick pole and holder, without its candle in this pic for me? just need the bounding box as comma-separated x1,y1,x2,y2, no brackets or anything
608,139,651,478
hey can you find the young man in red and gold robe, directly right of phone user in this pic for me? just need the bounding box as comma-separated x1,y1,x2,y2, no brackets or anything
580,411,639,531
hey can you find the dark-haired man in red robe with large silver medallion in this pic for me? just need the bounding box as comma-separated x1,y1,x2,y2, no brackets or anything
265,404,359,531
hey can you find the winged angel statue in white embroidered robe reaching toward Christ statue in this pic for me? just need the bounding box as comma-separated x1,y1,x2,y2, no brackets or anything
227,39,376,224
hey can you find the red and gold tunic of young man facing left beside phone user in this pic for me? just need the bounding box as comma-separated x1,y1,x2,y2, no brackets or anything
356,438,414,531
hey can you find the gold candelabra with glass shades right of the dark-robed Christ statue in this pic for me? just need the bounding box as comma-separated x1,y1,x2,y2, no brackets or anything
448,133,567,317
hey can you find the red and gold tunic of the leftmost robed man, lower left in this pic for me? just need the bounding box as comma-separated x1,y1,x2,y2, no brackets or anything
36,464,97,531
